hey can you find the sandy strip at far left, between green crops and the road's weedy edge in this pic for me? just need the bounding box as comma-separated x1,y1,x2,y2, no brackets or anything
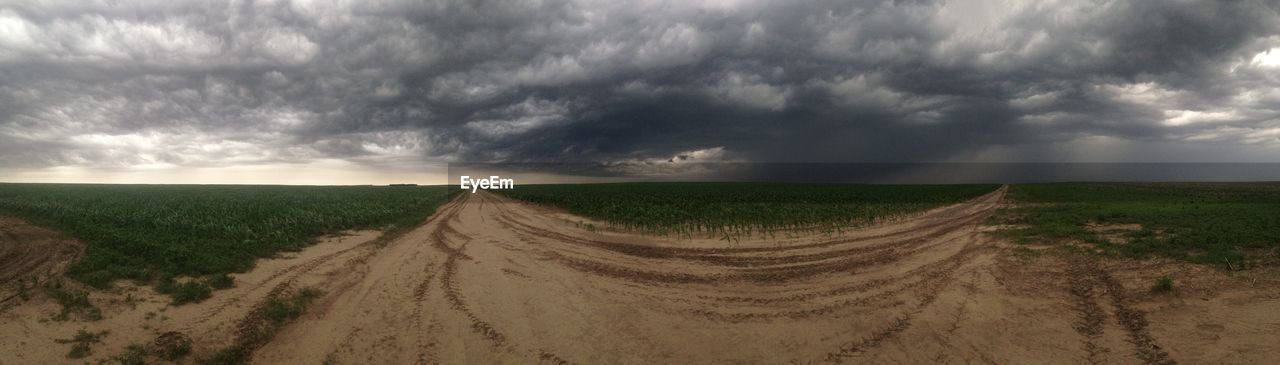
0,224,380,365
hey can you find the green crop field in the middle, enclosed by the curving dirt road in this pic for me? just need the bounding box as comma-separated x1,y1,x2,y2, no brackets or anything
495,182,998,233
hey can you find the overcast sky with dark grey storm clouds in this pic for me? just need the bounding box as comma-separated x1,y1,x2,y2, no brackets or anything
0,0,1280,184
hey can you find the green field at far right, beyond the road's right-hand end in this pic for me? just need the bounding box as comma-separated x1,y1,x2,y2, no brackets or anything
993,183,1280,266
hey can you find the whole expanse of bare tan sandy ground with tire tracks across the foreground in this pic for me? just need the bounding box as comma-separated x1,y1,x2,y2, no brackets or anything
0,185,1280,364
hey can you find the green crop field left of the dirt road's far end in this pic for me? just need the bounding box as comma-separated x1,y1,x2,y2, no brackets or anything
0,183,454,298
